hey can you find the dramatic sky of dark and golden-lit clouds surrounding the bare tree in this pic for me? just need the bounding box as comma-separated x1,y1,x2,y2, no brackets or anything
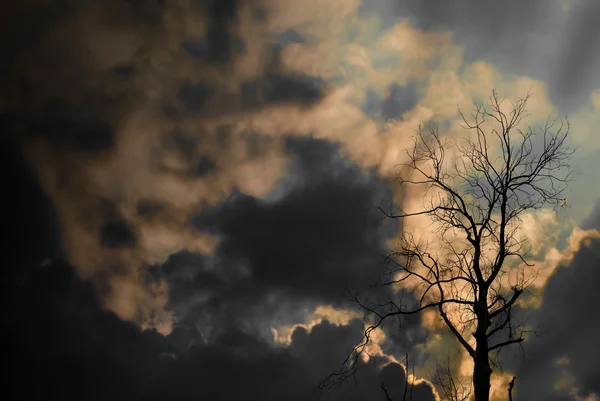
0,0,600,401
